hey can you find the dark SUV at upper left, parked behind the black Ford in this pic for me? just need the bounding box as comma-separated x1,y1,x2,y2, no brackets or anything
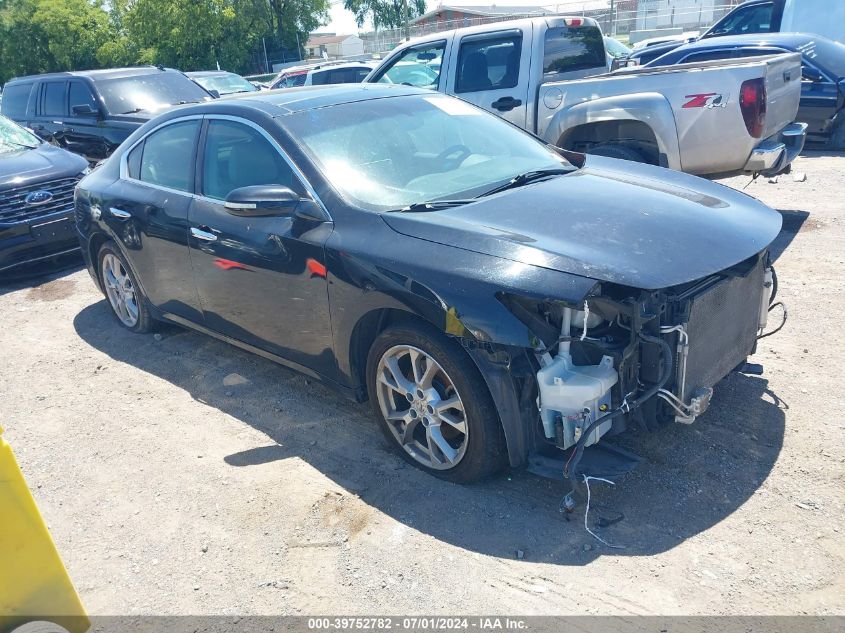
0,66,211,163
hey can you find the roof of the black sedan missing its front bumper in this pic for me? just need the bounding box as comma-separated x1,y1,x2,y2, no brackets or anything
199,84,426,116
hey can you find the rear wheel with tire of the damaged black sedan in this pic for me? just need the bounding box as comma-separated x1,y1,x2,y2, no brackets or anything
97,242,155,333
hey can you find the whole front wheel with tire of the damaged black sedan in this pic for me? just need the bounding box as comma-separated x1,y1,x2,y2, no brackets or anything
367,322,506,483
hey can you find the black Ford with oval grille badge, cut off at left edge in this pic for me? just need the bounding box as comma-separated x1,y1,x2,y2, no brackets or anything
0,116,88,277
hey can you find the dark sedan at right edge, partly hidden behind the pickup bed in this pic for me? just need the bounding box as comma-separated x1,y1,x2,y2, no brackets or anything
645,33,845,149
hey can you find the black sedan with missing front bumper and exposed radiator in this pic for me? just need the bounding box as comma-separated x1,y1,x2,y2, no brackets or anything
76,84,781,482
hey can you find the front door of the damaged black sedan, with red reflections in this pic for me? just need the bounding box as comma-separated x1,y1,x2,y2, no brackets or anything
189,117,335,376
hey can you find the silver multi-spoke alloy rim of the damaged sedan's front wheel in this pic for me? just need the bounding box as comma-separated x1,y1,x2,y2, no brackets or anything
376,345,469,470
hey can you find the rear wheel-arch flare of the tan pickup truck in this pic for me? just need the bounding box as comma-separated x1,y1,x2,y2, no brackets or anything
546,92,682,170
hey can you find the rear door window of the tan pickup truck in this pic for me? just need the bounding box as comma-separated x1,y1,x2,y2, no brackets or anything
455,35,522,93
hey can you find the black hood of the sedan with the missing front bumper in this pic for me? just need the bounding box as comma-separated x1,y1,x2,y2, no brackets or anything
382,156,781,290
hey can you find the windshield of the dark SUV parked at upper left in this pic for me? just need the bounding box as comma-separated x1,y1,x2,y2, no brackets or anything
96,71,209,114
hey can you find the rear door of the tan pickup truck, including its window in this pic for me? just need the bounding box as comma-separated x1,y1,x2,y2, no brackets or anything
446,26,531,128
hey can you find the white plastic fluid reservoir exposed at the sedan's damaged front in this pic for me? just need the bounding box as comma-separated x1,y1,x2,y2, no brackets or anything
537,349,619,448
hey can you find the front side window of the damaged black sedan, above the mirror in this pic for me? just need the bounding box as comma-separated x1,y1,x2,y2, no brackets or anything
202,119,302,200
